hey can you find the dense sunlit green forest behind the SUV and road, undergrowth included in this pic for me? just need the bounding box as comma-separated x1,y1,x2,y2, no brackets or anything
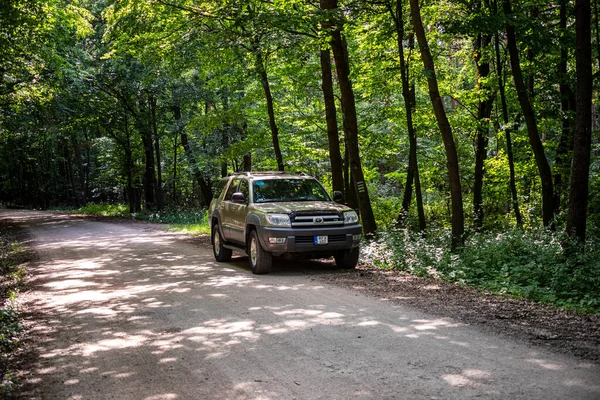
0,0,600,310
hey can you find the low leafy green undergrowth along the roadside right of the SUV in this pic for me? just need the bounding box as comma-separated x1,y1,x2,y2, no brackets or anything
362,229,600,313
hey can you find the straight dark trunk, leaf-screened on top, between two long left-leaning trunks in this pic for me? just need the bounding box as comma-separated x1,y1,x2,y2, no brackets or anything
473,34,494,231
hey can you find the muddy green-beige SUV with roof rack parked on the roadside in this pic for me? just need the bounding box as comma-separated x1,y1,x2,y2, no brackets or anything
209,172,361,274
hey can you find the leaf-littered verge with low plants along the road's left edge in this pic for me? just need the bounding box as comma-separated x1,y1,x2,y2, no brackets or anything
0,226,29,398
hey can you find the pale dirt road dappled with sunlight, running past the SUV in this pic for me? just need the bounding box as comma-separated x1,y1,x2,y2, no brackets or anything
0,211,600,400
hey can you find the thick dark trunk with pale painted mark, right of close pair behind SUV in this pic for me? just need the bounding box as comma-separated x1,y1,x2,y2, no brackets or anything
321,0,377,235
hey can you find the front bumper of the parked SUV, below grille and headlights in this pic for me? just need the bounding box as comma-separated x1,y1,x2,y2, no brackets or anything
259,224,362,254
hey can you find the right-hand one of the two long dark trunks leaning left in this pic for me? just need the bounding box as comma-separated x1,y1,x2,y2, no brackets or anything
502,0,554,227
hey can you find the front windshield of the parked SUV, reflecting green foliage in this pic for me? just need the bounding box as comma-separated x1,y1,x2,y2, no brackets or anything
252,179,331,203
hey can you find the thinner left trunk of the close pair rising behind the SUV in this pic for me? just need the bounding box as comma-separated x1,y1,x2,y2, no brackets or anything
321,48,344,193
